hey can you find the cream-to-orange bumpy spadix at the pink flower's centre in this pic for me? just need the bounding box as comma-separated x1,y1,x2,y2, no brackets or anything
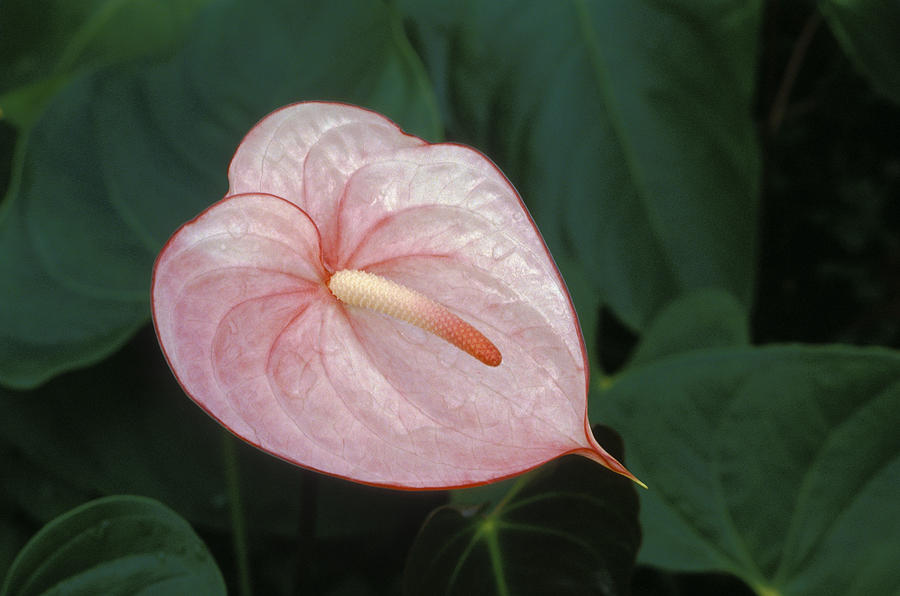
328,269,502,366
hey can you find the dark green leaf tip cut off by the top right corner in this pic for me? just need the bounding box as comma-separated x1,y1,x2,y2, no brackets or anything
819,0,900,104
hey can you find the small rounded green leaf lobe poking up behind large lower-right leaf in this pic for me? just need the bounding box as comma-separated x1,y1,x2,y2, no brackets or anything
628,289,750,366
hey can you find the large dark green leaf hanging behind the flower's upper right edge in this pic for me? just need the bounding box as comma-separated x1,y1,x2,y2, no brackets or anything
404,0,762,328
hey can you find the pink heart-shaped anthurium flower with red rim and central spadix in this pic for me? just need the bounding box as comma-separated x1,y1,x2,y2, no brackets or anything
152,102,644,489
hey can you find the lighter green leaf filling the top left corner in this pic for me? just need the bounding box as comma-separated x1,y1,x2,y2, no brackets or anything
0,0,209,128
